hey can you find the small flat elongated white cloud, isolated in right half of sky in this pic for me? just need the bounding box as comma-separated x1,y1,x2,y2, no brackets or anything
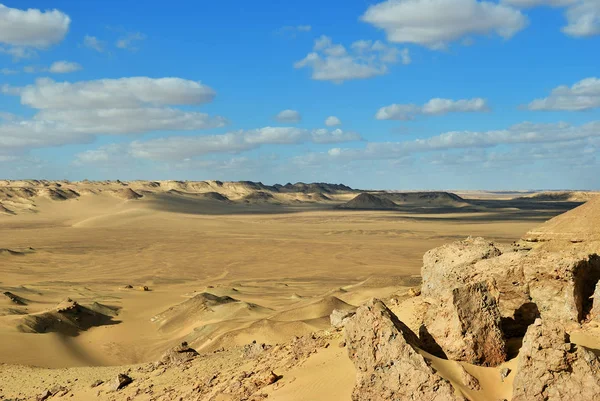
375,98,489,120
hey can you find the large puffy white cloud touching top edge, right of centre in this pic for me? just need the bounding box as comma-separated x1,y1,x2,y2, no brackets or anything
361,0,528,49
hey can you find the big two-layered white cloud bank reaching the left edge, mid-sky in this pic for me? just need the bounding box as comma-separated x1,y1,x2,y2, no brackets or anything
0,77,226,149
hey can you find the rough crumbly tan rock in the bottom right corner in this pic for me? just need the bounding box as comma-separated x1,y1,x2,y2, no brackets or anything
512,319,600,401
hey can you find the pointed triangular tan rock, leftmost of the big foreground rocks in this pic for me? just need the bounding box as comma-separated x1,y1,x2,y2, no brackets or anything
345,300,464,401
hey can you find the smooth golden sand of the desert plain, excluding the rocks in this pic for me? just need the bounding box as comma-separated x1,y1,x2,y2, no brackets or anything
0,182,589,400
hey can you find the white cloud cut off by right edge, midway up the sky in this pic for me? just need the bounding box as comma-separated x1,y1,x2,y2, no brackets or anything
527,77,600,111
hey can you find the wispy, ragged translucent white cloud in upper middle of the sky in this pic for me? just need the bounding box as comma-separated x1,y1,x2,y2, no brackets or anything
294,36,410,83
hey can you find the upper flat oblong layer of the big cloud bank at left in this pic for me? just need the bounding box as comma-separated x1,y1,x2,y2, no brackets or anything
21,77,215,109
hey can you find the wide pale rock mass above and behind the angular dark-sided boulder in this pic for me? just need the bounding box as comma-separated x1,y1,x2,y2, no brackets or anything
422,238,600,330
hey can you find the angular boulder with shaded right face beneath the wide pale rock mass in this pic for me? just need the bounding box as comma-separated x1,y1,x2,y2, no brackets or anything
420,282,506,366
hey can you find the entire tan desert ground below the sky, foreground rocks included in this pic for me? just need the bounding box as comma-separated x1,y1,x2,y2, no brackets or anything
0,181,600,401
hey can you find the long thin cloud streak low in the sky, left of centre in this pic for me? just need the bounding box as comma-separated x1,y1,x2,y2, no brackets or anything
131,127,360,160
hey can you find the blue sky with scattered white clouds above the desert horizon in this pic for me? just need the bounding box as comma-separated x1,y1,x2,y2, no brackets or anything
0,0,600,190
